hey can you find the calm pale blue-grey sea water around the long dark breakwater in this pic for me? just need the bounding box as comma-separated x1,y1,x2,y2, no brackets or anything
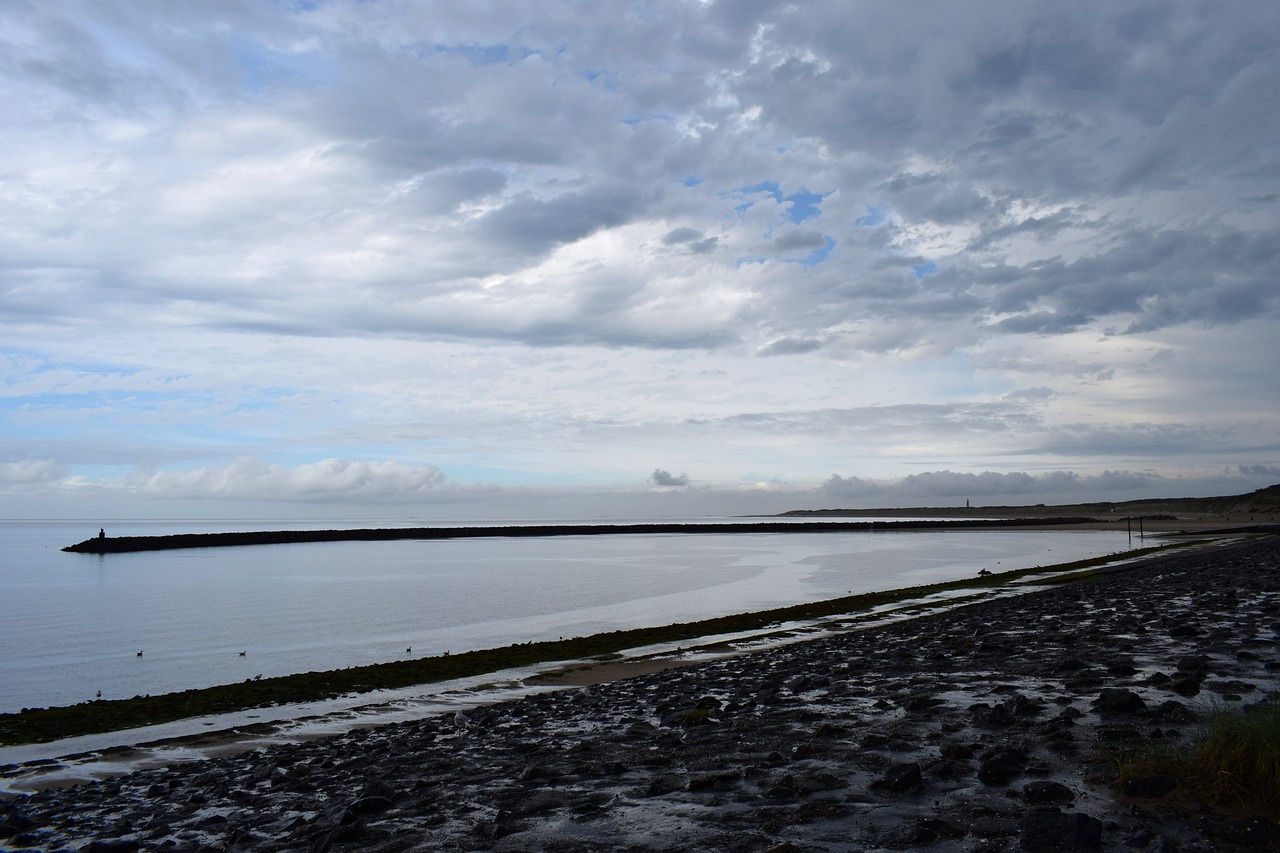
0,519,1128,712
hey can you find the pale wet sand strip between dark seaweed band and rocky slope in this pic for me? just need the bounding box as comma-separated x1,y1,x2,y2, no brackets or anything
0,537,1218,800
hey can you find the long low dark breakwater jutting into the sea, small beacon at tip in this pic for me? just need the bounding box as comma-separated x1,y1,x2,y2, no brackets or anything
63,516,1094,553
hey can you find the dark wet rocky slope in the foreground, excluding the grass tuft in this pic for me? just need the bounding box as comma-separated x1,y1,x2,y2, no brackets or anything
0,538,1280,853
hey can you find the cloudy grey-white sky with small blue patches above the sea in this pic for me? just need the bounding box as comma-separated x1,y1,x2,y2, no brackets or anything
0,0,1280,521
